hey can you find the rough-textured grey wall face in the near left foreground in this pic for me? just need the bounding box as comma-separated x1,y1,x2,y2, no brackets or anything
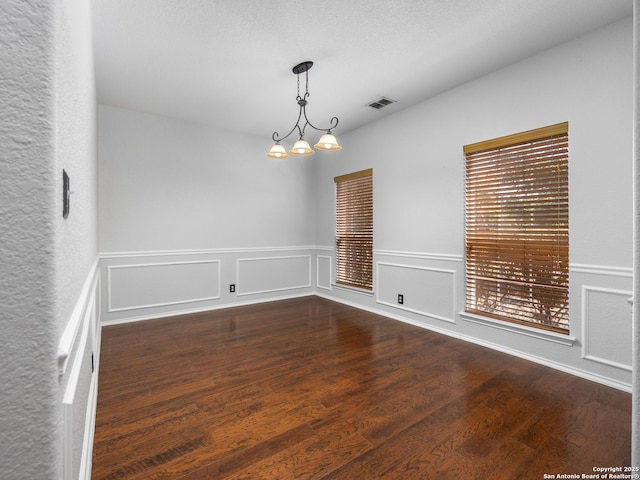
0,0,60,480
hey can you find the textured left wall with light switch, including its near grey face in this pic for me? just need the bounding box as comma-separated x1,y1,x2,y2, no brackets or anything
0,0,97,480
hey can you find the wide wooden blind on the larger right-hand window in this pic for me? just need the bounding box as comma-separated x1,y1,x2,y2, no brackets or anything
464,122,569,333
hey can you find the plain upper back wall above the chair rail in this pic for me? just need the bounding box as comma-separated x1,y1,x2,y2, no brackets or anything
98,106,314,253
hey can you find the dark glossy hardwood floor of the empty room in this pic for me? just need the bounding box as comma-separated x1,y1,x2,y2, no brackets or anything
92,297,631,480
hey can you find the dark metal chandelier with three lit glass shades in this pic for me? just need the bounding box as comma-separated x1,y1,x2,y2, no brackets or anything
267,62,342,158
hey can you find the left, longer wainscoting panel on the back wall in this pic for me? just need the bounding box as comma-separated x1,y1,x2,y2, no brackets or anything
107,260,220,313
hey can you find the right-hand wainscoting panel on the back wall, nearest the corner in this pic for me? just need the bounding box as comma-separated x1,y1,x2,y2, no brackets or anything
236,255,311,296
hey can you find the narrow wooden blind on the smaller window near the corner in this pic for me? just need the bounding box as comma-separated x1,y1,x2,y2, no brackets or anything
334,169,373,290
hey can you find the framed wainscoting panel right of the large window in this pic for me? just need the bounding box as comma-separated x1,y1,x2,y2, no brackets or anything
582,285,632,372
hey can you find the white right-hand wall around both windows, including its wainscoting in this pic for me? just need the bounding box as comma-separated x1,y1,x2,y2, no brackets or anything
316,18,633,390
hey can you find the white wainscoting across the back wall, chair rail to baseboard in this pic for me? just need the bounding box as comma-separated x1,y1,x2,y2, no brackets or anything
99,246,316,325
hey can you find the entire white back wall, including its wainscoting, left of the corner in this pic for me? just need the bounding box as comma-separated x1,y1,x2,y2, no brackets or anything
98,105,315,322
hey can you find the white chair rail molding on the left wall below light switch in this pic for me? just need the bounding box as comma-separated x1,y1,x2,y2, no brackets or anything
58,257,100,375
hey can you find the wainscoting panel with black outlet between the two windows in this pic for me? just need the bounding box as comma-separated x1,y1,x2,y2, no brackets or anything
376,262,456,322
